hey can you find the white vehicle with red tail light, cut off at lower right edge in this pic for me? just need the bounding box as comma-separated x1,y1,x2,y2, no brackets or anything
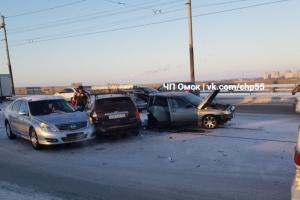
291,126,300,200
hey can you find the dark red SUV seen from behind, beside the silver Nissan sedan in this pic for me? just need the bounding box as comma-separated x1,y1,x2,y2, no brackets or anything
84,94,141,138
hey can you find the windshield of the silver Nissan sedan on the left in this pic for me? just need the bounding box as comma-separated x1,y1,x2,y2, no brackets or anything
29,99,76,116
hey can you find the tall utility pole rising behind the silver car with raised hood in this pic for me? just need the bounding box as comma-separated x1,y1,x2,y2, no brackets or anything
187,0,195,82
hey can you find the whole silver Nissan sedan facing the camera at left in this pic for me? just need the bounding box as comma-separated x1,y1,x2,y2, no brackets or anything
3,95,96,150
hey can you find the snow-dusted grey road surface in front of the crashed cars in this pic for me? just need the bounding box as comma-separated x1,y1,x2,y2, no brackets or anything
0,101,300,200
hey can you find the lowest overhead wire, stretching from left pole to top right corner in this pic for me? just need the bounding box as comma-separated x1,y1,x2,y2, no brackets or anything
2,0,290,47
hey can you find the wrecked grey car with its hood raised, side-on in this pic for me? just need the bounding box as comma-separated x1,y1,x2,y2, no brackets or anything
147,90,235,129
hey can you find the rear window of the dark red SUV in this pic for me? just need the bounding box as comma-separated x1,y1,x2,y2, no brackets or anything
95,97,135,111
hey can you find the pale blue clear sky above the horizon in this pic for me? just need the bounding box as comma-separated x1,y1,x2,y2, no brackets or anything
0,0,300,87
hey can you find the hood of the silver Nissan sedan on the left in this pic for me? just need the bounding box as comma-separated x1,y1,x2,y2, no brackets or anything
33,111,88,125
